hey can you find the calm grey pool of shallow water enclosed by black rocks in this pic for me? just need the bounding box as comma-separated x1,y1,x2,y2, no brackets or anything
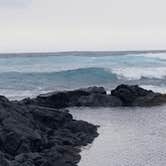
71,106,166,166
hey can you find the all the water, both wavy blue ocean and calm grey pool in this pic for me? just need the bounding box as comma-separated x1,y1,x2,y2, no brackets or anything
0,51,166,166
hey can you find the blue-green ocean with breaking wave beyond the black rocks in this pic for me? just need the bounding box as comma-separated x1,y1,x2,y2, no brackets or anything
0,51,166,99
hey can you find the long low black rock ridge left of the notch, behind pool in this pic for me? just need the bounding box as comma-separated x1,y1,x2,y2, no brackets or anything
24,87,122,108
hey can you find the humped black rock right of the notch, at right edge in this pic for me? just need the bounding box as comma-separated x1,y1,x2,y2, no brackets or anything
111,85,166,106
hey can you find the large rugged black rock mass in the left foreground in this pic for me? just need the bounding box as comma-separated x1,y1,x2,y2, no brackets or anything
0,96,97,166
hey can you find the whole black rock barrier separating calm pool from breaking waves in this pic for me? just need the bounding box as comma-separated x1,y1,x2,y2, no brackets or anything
21,85,166,108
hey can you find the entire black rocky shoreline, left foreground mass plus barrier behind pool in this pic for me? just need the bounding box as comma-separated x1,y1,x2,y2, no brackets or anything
0,85,166,166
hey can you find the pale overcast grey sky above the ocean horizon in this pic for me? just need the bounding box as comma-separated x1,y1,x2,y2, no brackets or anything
0,0,166,52
